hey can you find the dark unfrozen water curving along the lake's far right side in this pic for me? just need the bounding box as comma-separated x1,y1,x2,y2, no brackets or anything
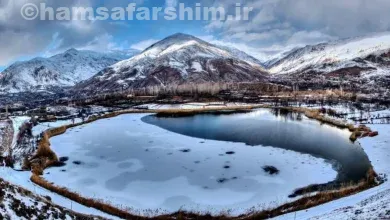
142,109,371,182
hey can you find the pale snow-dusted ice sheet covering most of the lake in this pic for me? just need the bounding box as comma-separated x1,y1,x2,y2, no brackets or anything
44,110,348,214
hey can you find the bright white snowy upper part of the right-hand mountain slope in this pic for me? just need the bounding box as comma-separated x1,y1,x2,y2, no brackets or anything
269,32,390,74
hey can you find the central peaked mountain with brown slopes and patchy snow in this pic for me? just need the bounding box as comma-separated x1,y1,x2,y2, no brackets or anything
76,34,267,90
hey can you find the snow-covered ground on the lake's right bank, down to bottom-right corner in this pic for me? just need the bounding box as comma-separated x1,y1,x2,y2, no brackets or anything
275,110,390,220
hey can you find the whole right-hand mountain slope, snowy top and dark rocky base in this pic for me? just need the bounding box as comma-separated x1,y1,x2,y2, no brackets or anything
269,33,390,93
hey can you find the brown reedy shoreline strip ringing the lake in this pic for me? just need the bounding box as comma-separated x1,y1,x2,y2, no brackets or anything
25,105,382,219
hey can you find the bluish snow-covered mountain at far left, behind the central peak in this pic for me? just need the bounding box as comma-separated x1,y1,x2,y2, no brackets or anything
0,49,138,93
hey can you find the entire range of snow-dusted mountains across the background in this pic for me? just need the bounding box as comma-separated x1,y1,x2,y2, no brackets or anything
0,32,390,94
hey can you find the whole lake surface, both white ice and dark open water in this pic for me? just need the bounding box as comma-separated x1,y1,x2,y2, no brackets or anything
44,110,369,214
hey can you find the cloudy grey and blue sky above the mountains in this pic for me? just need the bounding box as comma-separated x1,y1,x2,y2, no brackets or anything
0,0,390,70
